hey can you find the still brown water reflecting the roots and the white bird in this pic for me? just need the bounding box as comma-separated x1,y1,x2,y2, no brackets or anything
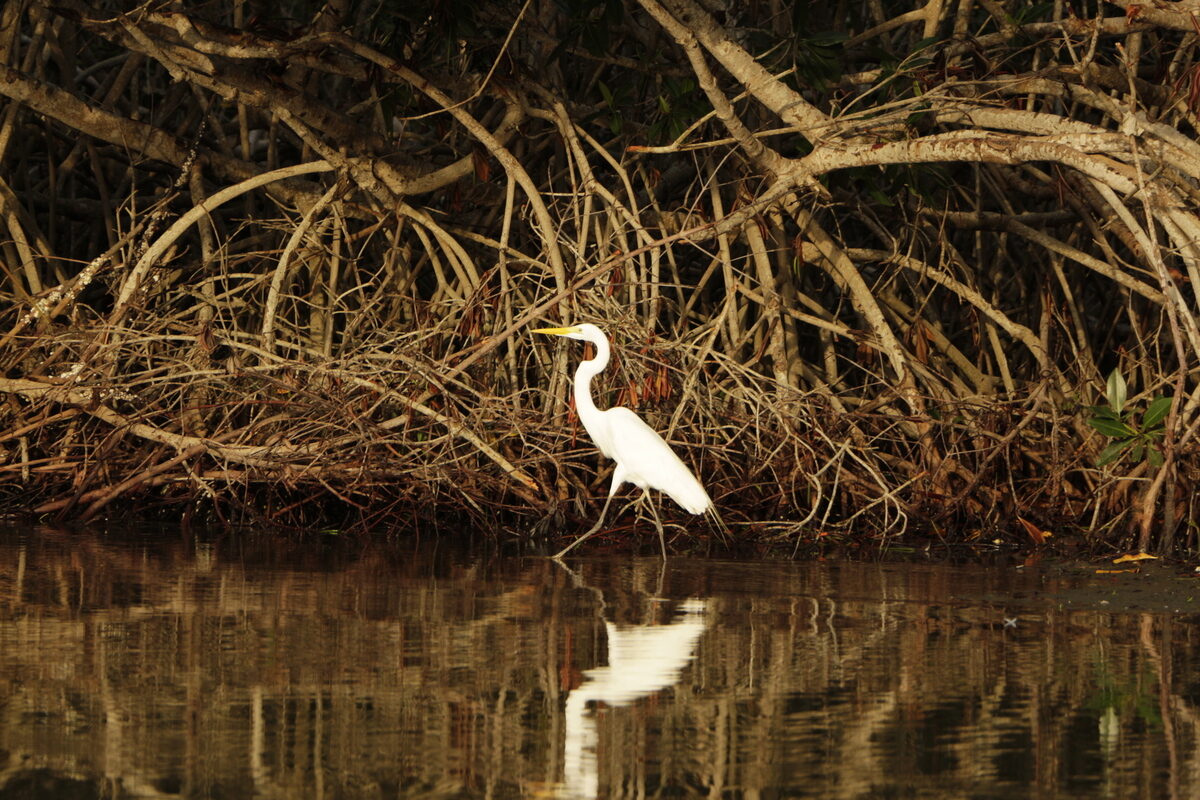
0,530,1200,799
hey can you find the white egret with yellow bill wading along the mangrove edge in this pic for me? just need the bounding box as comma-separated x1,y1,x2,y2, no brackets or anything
533,323,713,559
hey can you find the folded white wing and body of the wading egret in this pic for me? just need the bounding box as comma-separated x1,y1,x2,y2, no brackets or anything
598,407,713,513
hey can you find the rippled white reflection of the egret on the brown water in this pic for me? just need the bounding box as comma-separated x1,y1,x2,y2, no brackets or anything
558,600,708,799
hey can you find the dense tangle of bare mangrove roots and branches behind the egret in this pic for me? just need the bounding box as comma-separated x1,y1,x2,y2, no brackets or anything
0,0,1200,549
